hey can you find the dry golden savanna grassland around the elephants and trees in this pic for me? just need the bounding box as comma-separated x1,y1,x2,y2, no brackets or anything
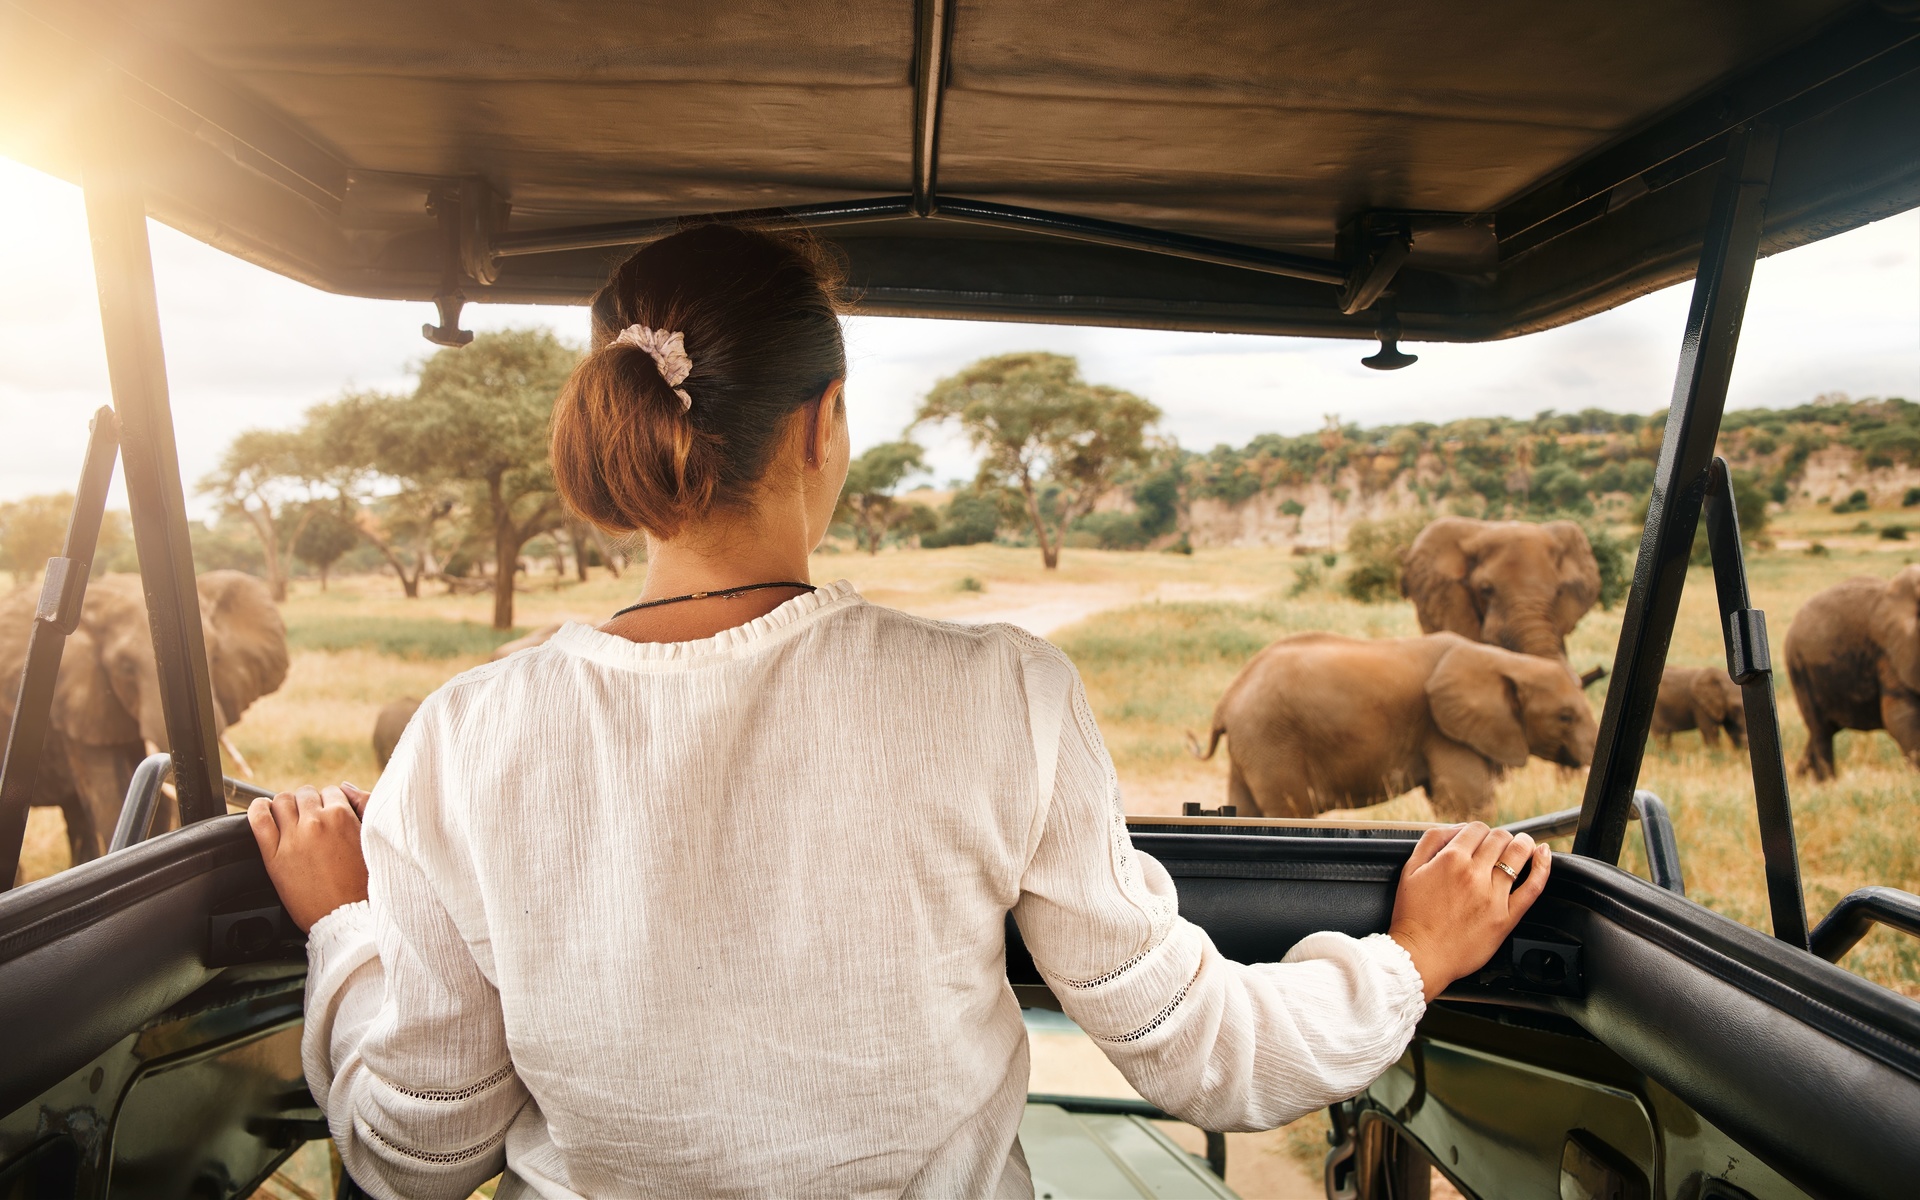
27,513,1920,995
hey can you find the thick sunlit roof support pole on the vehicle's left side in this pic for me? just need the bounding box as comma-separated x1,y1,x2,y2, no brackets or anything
84,126,227,824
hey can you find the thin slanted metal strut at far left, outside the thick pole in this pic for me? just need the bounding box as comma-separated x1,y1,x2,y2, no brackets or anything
0,409,119,891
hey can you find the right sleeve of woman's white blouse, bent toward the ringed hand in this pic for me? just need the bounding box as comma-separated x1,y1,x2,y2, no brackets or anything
1014,641,1427,1131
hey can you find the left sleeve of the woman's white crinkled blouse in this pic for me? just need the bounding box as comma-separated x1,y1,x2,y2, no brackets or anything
301,708,528,1200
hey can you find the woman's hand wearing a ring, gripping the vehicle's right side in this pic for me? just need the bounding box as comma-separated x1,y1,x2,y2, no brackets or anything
1388,822,1553,1002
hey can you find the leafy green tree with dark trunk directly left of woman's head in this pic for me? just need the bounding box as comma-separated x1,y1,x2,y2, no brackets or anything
384,330,580,630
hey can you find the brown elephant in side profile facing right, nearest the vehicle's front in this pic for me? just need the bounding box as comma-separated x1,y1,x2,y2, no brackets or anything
1192,634,1597,822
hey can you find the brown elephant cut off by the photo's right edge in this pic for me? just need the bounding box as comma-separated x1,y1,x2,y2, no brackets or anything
1788,566,1920,780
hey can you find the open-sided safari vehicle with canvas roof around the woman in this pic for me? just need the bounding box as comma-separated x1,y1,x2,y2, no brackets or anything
0,0,1920,1200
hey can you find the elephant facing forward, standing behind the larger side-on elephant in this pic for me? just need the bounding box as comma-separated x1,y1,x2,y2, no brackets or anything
1400,516,1599,659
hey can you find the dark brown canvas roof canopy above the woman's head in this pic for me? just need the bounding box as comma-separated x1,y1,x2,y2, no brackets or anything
0,0,1920,340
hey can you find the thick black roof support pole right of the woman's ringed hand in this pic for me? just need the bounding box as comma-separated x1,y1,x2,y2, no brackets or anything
1572,125,1780,862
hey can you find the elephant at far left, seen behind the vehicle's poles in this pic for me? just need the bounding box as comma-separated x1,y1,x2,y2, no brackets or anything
0,570,286,862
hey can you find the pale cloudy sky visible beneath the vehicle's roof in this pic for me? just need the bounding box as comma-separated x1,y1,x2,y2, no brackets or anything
0,159,1920,515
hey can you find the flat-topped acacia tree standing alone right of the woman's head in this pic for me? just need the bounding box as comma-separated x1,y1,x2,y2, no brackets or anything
916,351,1160,570
